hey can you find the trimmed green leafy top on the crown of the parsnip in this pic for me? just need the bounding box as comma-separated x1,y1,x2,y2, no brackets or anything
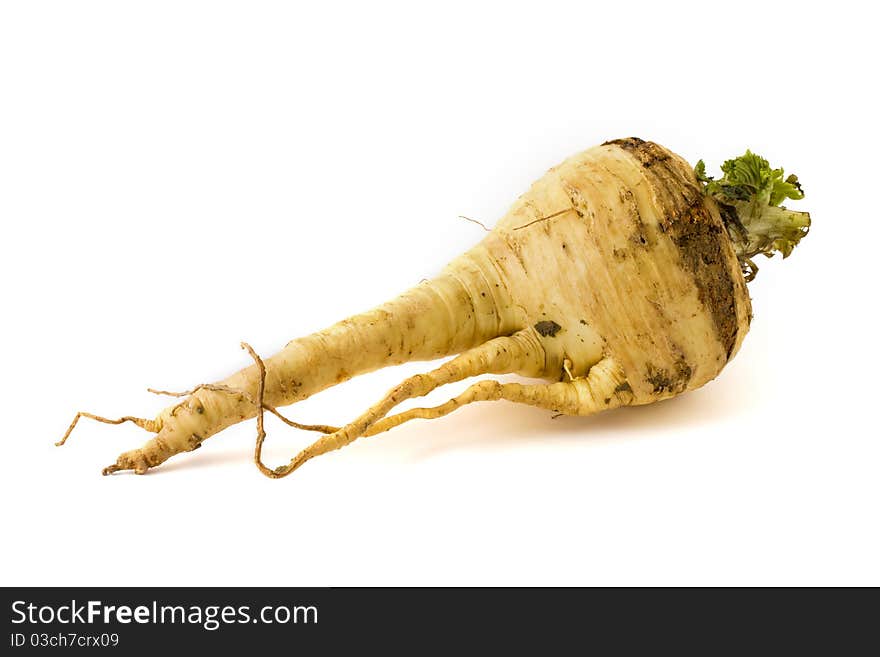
694,150,810,281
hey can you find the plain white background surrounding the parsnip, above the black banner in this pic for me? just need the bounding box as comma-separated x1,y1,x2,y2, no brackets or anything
0,1,880,585
